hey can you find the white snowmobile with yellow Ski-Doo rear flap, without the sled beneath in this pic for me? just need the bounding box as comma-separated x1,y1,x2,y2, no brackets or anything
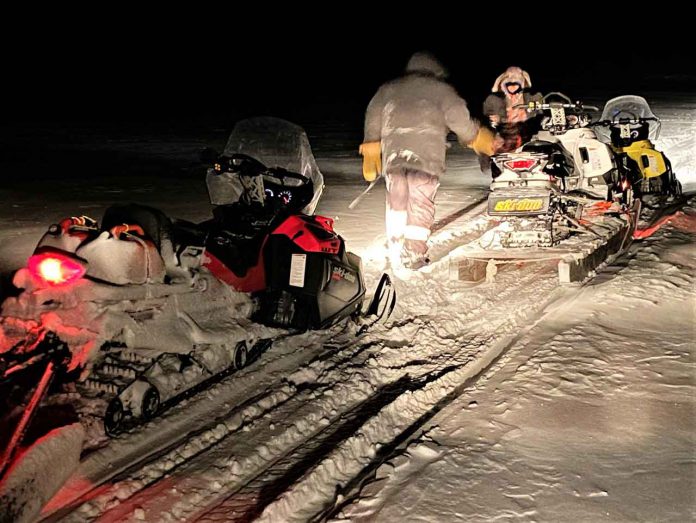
488,93,615,248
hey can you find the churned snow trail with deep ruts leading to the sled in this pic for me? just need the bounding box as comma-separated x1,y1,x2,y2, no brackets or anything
55,250,556,521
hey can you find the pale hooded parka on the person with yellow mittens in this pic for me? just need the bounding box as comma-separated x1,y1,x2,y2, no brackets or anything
364,53,479,176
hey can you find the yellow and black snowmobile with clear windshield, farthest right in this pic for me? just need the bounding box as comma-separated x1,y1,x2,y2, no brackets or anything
593,95,682,201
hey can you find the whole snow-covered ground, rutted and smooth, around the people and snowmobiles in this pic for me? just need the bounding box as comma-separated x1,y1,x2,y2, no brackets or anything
0,96,696,521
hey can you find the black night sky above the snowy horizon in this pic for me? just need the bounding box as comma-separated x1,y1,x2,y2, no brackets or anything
3,11,696,124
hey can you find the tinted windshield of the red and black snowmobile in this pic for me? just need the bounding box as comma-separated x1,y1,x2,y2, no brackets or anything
215,117,324,214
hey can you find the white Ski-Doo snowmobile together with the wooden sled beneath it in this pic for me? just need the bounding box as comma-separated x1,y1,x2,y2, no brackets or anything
456,93,639,282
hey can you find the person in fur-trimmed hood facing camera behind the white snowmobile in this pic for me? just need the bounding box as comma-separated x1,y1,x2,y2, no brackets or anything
481,66,542,177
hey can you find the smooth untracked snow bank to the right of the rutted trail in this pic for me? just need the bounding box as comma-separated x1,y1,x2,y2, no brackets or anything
333,200,696,522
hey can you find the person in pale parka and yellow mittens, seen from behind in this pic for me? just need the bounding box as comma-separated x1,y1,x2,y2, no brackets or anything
360,52,494,268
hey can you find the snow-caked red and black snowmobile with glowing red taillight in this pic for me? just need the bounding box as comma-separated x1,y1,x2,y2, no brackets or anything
0,118,396,475
